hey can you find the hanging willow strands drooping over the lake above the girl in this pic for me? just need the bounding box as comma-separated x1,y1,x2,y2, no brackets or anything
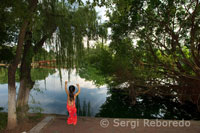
53,6,98,69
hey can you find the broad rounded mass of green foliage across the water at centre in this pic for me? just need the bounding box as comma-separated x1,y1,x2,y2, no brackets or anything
79,38,164,89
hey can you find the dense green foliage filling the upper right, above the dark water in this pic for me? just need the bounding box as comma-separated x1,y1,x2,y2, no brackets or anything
104,0,200,94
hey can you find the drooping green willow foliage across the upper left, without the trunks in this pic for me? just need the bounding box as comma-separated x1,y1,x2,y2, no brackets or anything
0,0,105,69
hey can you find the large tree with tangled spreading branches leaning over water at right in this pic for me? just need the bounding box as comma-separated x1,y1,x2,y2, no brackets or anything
107,0,200,109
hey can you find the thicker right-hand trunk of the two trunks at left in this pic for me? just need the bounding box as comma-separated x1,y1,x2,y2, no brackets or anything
17,31,34,122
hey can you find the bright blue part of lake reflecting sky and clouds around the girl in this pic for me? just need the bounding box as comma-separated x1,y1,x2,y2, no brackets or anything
0,68,108,116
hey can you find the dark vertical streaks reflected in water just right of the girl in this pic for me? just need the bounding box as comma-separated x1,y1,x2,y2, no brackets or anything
76,96,91,116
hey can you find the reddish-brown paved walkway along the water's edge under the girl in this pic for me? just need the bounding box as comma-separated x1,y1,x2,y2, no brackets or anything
29,116,200,133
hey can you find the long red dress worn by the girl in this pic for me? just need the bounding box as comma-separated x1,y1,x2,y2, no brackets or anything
67,100,77,125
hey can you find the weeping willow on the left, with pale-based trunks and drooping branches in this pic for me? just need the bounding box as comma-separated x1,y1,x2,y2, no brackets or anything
1,0,103,129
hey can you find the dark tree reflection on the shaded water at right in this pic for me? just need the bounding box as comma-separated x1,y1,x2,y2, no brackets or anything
96,89,200,120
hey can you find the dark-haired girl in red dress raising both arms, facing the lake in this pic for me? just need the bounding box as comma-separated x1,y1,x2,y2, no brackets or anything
65,81,80,125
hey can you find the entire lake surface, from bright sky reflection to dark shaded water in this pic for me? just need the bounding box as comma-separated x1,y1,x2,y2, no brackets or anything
0,68,200,120
